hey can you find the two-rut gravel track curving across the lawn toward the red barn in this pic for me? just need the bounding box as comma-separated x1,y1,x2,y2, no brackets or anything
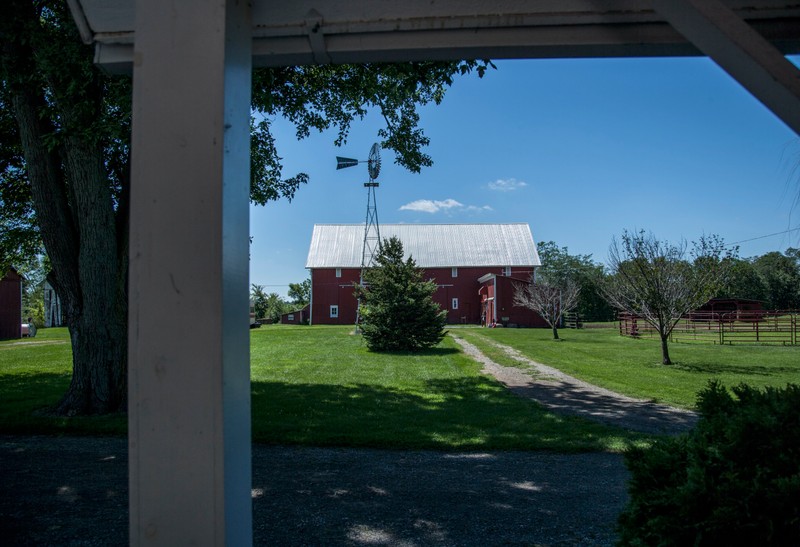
451,333,697,434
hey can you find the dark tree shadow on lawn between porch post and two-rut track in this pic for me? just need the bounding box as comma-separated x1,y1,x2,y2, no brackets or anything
252,378,635,452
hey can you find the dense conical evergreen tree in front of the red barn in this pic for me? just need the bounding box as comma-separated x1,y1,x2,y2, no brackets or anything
356,237,447,351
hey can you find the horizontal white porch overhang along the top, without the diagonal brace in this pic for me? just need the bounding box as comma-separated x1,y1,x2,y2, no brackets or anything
70,0,800,65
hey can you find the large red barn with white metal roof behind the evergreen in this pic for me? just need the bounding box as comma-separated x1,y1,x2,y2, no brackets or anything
306,223,546,326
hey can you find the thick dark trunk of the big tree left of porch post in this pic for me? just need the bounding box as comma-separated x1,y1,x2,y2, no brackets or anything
0,0,128,416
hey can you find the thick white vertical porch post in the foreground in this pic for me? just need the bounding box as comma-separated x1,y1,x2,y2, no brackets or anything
129,0,252,546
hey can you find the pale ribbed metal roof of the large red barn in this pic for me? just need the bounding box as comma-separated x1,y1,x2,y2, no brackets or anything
306,223,541,268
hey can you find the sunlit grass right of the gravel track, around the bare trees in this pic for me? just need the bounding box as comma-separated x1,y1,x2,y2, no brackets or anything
456,329,800,408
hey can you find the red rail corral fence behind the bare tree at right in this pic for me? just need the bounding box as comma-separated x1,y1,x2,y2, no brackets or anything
618,310,800,346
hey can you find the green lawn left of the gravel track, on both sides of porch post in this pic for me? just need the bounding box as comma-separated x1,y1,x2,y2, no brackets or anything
0,325,649,452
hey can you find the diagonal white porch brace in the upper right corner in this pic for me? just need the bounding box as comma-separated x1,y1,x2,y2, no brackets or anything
653,0,800,135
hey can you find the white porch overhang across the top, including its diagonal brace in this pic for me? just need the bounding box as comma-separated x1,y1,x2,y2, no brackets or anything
68,0,800,134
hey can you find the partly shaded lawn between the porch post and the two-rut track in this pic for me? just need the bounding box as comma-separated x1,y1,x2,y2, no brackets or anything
251,326,644,451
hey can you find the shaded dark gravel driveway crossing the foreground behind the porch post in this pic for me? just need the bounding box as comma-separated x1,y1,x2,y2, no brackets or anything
0,436,628,547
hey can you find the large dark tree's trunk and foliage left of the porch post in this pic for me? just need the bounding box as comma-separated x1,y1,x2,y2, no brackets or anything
0,0,130,415
